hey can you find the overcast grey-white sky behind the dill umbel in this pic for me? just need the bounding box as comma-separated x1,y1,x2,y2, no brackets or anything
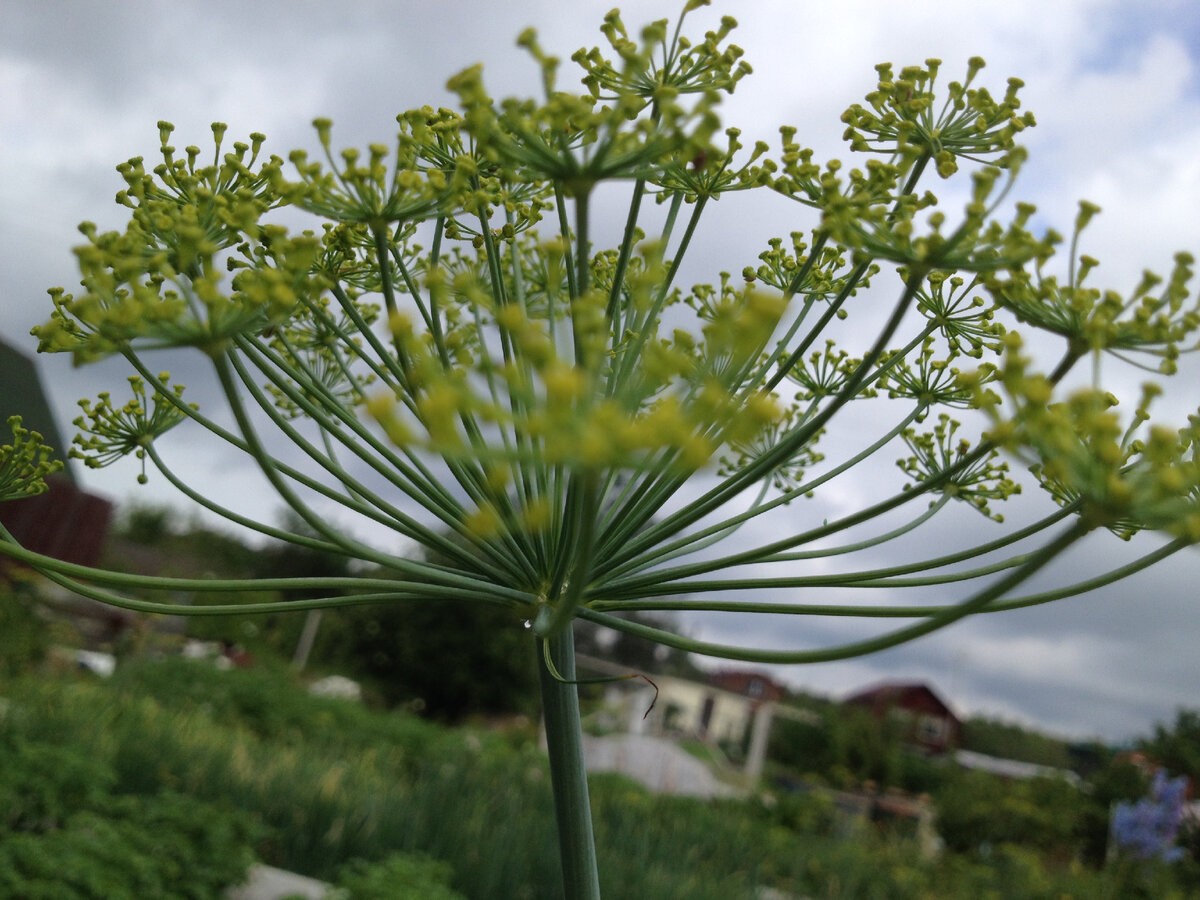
0,0,1200,739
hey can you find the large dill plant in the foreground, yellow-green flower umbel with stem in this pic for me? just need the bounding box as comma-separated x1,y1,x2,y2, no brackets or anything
0,0,1200,898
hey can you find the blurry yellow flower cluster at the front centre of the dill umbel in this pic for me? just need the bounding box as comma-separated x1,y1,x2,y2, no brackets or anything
367,243,781,470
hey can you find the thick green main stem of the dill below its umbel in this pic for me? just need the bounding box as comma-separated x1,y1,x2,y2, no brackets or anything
538,628,600,900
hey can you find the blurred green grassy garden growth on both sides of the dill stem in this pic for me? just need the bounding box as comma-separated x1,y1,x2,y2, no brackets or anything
0,660,1180,900
